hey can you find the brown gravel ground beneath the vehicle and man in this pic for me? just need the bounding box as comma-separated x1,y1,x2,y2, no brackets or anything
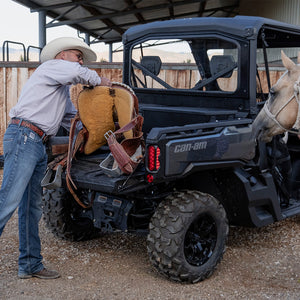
0,170,300,300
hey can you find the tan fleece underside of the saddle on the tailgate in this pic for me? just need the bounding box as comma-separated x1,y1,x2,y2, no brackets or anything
77,84,138,154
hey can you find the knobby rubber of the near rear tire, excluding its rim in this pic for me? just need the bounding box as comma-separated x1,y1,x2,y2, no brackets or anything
147,191,229,283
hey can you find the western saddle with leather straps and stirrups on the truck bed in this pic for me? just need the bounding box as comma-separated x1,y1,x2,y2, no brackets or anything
42,83,144,207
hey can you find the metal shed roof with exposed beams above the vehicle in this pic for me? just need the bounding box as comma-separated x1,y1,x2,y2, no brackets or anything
13,0,240,43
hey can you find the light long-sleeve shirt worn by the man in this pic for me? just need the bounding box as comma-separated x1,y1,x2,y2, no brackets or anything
9,59,101,135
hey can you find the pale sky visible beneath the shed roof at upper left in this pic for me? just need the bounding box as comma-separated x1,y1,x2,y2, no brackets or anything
0,0,108,52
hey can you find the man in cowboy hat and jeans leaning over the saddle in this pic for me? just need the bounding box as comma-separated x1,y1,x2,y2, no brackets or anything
0,37,111,279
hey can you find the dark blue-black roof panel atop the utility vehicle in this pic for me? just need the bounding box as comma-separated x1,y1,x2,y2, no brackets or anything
123,15,300,44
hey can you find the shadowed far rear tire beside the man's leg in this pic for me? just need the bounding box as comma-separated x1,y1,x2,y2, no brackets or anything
43,187,99,241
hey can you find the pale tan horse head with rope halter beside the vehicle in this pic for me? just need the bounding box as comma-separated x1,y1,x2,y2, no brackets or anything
252,51,300,142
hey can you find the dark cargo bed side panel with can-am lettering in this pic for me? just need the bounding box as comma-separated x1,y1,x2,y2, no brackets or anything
146,119,255,179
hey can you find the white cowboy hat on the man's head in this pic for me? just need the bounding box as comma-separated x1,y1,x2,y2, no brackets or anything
41,37,97,63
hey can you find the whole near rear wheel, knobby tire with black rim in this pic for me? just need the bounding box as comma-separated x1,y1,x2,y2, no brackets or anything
147,191,229,283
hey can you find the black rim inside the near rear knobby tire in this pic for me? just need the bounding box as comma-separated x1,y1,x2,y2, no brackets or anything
184,214,218,266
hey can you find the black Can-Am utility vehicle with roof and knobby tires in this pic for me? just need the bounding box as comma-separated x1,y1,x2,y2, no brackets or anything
44,16,300,283
